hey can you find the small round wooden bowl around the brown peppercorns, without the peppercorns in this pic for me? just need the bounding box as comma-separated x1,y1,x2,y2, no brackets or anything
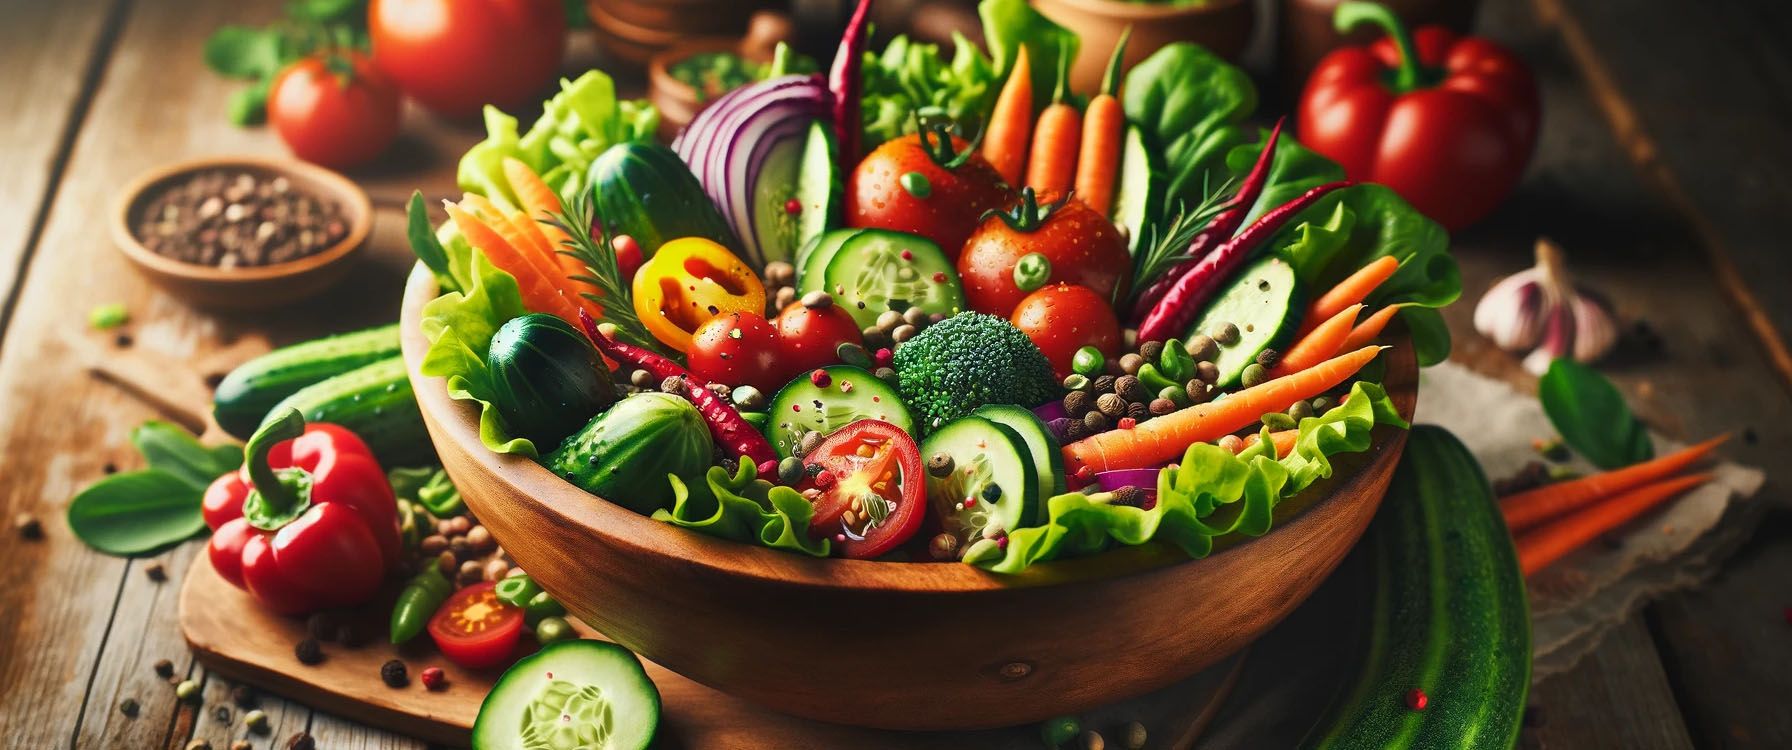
111,156,373,310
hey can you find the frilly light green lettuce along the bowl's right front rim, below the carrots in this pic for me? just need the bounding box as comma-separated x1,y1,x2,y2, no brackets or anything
964,381,1407,573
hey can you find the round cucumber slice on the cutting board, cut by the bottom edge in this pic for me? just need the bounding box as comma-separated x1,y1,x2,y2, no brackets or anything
473,641,659,750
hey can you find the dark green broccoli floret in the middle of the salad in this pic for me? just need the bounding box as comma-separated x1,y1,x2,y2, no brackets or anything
896,313,1059,431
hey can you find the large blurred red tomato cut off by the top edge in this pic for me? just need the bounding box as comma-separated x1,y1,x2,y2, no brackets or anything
367,0,566,116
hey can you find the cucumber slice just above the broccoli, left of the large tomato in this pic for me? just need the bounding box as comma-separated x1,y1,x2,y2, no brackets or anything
801,229,966,328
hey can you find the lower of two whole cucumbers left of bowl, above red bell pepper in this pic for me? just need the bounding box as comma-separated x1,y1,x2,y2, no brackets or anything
269,356,435,465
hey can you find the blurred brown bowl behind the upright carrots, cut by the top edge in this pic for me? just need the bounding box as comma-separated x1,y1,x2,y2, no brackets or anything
1034,0,1256,95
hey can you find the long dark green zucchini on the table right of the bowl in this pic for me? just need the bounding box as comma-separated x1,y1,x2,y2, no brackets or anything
1305,426,1530,750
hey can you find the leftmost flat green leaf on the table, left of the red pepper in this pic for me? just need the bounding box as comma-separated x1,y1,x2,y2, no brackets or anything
68,469,206,557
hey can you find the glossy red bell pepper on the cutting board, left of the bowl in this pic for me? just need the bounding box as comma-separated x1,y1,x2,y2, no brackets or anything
204,410,400,614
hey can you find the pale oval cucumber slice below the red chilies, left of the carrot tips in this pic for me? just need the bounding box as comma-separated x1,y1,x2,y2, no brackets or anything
1185,256,1306,388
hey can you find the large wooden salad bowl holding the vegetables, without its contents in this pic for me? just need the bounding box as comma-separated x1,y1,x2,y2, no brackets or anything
401,265,1417,730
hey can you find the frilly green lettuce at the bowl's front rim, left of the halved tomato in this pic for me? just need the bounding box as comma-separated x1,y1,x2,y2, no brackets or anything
654,460,828,557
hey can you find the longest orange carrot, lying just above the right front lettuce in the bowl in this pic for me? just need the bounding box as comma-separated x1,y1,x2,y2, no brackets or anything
1064,347,1382,476
